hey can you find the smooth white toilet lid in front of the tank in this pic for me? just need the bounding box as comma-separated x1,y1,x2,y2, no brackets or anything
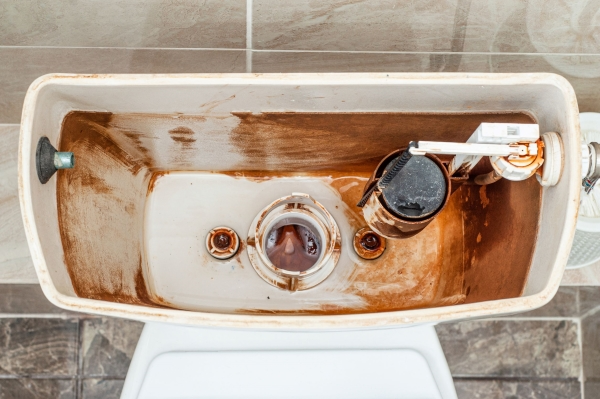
138,349,442,399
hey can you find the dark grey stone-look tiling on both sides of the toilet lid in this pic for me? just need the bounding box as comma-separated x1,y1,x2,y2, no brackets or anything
0,284,600,399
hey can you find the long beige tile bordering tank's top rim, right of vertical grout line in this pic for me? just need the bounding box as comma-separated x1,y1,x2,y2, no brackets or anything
252,51,600,112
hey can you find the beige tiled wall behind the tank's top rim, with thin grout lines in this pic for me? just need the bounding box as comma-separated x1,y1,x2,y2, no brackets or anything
0,0,600,123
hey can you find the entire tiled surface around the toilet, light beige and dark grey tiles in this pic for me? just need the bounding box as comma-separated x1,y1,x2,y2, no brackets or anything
0,0,600,399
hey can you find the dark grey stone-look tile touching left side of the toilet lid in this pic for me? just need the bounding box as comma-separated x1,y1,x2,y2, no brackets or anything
81,318,144,378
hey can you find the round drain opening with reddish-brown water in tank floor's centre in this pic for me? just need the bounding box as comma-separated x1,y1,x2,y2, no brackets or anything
265,219,323,272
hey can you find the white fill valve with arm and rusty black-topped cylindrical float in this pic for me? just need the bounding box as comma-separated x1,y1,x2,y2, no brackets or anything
357,123,564,238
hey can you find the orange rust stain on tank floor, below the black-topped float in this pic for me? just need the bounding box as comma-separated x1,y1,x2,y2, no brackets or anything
340,188,463,313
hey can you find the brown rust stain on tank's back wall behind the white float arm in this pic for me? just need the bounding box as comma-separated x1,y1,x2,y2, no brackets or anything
230,112,532,174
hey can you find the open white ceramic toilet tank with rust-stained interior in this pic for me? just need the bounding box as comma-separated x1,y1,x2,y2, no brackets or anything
19,73,581,330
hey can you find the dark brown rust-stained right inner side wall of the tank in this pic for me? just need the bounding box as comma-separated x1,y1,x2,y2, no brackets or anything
463,177,541,303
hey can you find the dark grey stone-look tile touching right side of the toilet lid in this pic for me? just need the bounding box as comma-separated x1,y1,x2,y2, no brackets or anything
436,320,581,378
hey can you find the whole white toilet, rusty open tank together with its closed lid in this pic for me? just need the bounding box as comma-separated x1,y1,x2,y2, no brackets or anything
19,74,581,398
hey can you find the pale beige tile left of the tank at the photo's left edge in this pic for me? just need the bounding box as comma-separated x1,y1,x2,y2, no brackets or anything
0,126,37,282
